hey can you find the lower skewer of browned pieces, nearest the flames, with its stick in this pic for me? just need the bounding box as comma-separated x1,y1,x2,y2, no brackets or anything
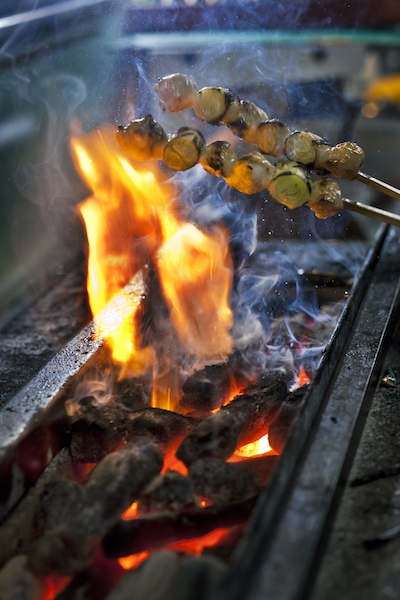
116,115,400,226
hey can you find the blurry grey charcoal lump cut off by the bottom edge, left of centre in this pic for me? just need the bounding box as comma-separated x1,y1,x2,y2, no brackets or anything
103,550,179,600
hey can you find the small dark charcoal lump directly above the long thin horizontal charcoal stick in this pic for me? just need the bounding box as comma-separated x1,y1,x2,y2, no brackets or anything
138,471,199,514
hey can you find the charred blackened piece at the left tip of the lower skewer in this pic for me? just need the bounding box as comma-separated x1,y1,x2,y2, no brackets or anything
115,115,168,160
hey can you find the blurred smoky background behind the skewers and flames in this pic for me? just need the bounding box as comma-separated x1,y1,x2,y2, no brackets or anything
0,0,400,325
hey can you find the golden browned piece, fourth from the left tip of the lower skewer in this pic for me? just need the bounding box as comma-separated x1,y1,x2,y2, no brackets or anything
226,152,274,194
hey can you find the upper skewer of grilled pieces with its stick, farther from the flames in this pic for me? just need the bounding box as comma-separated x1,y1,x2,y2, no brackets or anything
154,73,400,200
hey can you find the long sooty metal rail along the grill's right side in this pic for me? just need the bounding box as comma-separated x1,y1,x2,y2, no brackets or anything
221,225,400,600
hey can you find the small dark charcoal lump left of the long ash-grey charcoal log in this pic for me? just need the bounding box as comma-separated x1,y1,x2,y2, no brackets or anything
32,479,83,539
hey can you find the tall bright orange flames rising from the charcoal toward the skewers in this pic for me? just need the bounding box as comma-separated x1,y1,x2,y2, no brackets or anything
71,126,232,410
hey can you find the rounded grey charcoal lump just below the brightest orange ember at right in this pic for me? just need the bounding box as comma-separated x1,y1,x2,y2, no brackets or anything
189,458,260,505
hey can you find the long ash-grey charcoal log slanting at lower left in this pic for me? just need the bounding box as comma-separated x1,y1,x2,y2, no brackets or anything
29,439,163,575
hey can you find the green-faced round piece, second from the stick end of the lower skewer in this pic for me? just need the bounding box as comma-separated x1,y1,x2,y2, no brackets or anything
269,160,312,208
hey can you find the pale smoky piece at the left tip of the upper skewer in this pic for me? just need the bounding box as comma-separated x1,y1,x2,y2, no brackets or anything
154,73,197,112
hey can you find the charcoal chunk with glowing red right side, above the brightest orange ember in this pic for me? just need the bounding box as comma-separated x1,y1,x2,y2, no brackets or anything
176,380,287,467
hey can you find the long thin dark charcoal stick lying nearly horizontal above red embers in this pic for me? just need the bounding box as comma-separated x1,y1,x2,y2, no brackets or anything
103,498,256,558
